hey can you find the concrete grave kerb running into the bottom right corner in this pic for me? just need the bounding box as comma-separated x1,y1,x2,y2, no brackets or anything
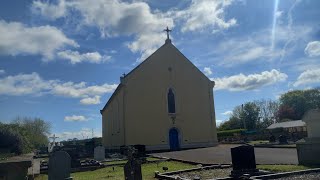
250,168,320,180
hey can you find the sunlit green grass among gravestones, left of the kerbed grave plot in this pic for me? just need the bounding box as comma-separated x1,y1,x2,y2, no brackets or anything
35,161,196,180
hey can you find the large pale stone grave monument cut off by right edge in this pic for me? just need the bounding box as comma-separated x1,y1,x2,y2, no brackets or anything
297,109,320,165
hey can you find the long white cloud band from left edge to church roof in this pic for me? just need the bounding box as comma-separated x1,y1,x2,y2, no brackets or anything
0,73,117,104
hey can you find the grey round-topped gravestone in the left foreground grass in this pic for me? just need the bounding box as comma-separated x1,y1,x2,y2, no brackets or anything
48,151,71,180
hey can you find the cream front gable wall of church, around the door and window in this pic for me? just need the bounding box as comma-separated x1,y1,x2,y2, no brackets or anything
124,44,217,149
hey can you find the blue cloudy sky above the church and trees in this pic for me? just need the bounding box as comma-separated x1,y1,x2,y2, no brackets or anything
0,0,320,140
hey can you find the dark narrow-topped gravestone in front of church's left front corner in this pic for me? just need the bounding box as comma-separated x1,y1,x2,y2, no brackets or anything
124,147,142,180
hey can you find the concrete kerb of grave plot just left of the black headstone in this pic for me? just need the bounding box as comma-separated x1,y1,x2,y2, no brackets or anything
155,165,231,180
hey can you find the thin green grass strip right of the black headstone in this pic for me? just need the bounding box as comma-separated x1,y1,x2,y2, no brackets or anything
257,165,316,172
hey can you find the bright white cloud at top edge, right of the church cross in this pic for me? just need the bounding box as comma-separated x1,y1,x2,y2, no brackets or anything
173,0,237,32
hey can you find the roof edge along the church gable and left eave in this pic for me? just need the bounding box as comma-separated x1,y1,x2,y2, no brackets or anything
100,38,211,114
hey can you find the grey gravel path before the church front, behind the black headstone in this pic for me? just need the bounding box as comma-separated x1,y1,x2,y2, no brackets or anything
152,145,298,164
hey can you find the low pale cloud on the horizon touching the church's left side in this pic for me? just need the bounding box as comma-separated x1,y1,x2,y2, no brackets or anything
56,128,102,141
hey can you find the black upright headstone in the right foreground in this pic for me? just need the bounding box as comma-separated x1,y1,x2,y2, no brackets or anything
231,145,258,177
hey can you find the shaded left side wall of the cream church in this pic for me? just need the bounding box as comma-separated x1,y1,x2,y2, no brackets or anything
102,88,124,149
